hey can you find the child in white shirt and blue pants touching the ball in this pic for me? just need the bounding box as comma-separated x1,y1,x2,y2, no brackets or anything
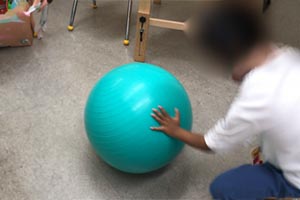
151,3,300,200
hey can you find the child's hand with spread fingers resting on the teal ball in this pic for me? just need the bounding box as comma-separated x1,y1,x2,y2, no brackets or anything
151,106,180,137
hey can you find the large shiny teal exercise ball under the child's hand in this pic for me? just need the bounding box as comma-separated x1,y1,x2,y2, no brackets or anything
84,63,192,174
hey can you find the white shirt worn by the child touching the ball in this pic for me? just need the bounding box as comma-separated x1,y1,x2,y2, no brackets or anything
204,48,300,189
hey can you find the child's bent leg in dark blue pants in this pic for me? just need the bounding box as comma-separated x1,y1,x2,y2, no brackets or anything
210,163,300,200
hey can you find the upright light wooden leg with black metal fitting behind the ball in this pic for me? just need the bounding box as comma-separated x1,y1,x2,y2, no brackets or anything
134,0,151,62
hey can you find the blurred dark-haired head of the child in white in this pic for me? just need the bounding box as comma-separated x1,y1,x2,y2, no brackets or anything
197,5,267,63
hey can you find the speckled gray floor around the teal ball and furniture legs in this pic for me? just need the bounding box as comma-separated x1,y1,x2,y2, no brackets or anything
0,0,300,200
